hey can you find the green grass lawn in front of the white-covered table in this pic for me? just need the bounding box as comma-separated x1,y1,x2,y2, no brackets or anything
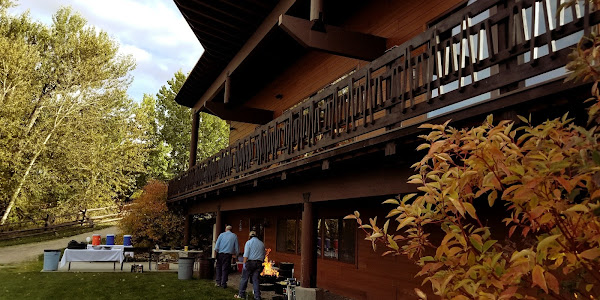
0,255,241,300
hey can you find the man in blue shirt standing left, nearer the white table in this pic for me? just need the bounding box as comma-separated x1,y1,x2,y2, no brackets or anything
215,225,240,289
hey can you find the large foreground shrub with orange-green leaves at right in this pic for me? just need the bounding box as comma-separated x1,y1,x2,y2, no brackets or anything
346,11,600,300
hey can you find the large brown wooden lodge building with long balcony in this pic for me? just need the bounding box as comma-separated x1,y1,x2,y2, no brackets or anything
168,0,600,299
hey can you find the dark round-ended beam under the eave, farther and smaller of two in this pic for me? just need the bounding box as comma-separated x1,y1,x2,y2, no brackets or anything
204,101,275,125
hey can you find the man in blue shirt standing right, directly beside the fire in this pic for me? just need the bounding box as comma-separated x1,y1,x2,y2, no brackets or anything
234,231,265,299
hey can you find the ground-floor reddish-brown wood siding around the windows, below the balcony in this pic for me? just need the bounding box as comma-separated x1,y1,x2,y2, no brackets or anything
223,202,426,300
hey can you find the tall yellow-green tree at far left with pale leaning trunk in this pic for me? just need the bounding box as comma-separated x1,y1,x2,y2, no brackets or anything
0,1,144,223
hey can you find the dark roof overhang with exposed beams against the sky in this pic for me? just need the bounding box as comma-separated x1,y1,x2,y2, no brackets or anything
175,0,386,124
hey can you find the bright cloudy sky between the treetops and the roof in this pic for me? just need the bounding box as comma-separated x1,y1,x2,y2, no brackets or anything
12,0,203,101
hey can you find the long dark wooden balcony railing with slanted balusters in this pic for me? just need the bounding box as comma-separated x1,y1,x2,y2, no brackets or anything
168,0,600,200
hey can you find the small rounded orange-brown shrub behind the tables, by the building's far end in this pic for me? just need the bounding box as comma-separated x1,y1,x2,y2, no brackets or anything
119,181,184,247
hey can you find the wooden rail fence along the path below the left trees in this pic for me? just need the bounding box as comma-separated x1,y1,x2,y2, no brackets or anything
0,205,125,240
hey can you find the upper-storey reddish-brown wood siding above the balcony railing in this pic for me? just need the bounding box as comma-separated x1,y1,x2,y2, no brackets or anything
229,0,463,144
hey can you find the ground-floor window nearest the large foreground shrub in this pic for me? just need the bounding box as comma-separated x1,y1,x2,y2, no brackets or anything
317,218,356,263
